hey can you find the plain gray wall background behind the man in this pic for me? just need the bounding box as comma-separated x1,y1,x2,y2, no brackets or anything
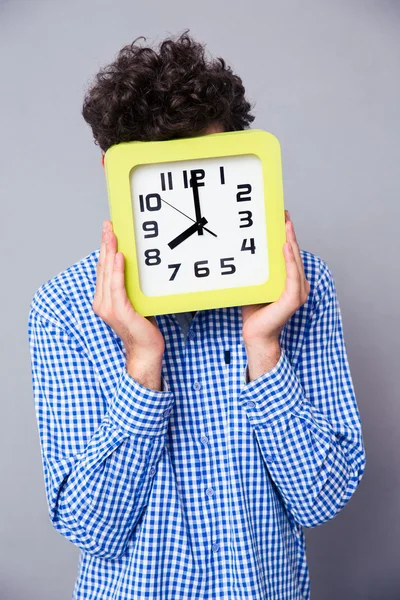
0,0,400,600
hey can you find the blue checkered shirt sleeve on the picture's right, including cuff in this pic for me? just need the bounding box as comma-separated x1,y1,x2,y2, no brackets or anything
239,261,365,527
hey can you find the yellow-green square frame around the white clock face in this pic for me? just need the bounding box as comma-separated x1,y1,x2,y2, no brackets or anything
104,129,286,316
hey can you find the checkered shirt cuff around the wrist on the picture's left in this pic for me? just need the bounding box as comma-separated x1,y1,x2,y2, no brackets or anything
108,366,174,436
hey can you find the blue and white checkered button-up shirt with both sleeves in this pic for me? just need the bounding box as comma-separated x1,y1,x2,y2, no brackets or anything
29,249,365,600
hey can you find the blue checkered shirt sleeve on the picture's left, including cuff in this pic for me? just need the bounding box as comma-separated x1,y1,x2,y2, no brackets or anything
28,309,174,558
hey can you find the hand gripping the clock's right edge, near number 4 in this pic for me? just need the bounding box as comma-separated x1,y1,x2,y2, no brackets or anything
242,210,310,348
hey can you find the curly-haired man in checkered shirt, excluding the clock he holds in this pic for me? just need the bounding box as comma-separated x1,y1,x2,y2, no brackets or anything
29,32,365,600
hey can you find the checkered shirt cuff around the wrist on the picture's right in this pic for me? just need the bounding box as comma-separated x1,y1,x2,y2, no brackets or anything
239,348,304,426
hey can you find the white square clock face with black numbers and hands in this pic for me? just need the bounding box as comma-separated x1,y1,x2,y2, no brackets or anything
130,154,269,296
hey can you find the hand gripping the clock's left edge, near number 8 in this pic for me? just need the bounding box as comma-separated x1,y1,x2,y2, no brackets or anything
92,221,165,364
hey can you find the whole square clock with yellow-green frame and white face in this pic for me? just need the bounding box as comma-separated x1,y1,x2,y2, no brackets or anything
104,129,286,316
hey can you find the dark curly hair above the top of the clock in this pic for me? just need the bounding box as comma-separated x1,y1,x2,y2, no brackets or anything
82,30,255,152
